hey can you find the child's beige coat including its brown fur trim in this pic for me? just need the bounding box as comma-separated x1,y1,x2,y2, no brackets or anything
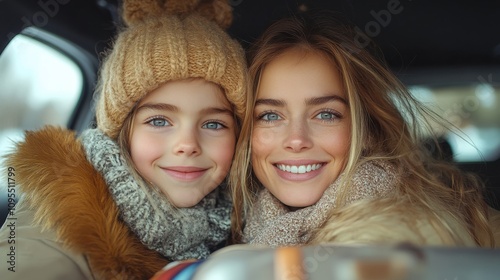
0,128,167,280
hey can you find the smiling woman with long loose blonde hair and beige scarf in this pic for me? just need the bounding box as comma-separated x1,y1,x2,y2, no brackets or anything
230,10,500,247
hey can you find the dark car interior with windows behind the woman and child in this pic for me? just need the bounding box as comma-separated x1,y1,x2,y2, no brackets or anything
0,0,500,278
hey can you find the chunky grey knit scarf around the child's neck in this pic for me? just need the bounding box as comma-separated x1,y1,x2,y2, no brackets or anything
81,129,231,261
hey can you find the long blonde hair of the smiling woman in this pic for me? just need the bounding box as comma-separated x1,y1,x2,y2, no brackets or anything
230,11,494,247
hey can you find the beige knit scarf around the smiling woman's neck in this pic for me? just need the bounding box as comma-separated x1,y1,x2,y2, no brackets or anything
243,161,396,247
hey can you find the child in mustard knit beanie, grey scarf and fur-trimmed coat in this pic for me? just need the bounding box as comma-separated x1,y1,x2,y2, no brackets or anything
0,0,247,279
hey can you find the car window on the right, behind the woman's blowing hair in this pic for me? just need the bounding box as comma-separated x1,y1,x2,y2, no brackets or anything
410,83,500,162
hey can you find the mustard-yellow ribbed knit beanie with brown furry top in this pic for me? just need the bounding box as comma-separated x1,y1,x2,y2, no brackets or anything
96,0,247,139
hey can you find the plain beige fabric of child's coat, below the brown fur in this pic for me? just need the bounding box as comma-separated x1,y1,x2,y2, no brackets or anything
0,200,94,280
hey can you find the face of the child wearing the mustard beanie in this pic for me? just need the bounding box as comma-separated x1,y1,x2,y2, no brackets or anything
130,79,236,207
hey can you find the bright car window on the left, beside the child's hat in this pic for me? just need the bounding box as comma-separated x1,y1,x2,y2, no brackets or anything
0,34,83,160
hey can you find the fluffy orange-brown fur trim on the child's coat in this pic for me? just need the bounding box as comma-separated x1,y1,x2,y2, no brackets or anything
6,127,167,279
